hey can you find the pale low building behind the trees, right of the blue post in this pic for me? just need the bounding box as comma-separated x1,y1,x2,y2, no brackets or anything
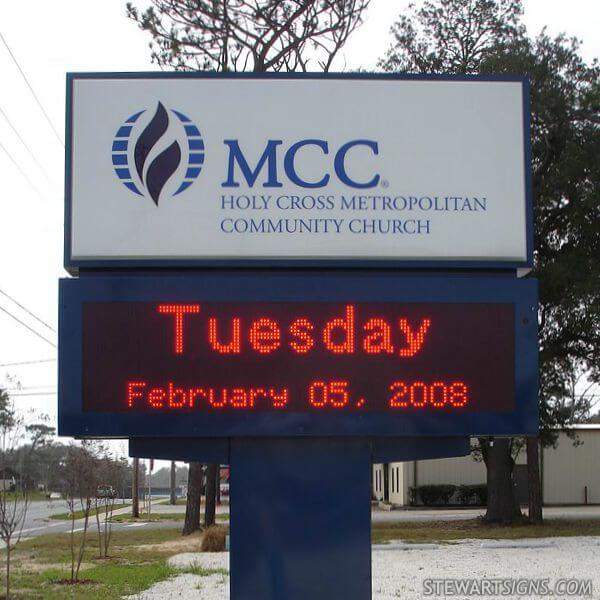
373,425,600,506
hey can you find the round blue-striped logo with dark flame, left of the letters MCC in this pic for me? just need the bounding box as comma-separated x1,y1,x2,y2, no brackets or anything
112,102,204,206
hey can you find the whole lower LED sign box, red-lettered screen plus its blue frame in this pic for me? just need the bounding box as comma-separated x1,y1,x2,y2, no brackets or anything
59,273,537,436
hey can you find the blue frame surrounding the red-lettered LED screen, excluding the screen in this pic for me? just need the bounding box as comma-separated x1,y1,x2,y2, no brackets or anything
58,270,538,438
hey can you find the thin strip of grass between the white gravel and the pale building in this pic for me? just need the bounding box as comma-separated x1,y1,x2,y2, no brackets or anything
371,519,600,544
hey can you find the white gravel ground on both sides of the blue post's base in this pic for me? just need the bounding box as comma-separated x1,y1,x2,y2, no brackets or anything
129,537,600,600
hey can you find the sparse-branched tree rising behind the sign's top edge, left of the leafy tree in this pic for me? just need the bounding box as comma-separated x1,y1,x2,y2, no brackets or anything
127,0,371,72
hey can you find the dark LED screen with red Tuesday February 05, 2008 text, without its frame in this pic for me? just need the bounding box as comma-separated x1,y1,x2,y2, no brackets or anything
82,302,515,414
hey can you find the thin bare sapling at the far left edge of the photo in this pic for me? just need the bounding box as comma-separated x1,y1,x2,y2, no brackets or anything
0,389,54,599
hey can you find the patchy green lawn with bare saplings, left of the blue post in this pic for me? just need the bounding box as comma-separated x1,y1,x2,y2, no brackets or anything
1,528,227,600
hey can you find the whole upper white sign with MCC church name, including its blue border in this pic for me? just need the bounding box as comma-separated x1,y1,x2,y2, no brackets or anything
66,74,531,268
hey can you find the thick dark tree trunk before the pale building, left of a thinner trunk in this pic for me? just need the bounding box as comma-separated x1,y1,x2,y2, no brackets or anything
479,438,521,524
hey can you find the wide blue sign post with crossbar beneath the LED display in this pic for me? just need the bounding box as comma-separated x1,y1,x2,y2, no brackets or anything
129,437,470,600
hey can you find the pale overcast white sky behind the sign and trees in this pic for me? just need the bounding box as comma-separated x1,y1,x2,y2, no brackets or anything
0,0,600,447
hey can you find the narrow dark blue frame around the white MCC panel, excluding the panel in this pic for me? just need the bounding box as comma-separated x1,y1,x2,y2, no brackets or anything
64,72,533,274
